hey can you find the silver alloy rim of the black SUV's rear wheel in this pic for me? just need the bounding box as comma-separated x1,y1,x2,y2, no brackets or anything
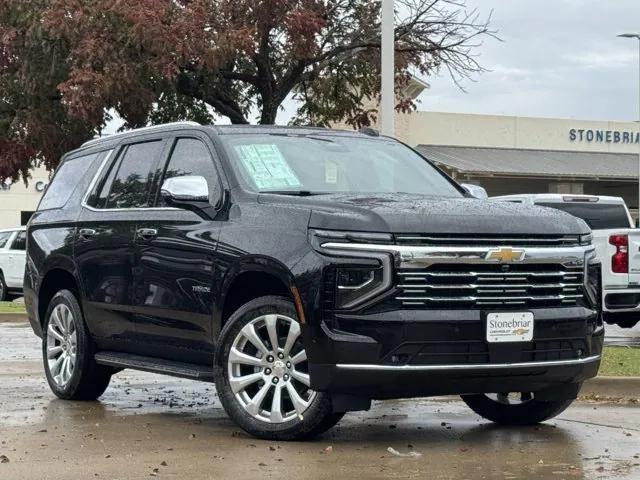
47,304,78,388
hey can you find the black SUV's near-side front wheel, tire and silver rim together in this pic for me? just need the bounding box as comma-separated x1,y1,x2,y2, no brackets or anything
214,296,344,440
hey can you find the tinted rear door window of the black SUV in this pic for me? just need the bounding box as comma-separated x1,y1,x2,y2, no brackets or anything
106,141,163,208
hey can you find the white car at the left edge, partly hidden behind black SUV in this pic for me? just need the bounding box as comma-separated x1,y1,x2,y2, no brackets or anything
0,227,27,301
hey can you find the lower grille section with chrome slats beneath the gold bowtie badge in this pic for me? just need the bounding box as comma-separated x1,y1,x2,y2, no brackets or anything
396,264,584,309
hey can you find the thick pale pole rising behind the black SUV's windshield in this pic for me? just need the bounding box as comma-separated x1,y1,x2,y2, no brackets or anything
380,0,396,137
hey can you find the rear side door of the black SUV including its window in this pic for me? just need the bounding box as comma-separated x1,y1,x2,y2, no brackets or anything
74,137,166,353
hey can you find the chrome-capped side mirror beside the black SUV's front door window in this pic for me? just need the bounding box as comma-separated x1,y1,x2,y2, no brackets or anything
160,175,216,220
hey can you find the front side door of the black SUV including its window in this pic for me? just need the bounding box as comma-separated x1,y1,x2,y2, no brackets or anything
135,137,221,364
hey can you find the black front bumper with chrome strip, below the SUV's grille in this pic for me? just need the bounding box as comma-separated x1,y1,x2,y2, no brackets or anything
305,307,604,399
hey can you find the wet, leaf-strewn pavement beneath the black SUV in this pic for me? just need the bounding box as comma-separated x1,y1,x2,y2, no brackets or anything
0,324,640,480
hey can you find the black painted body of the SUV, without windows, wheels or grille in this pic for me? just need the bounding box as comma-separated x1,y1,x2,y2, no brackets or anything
25,126,602,398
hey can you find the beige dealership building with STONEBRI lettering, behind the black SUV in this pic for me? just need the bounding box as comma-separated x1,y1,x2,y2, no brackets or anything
0,109,640,228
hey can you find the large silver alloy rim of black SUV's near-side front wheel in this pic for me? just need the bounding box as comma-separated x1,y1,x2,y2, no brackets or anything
227,314,316,423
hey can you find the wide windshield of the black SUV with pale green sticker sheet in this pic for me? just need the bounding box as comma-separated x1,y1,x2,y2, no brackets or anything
222,134,463,197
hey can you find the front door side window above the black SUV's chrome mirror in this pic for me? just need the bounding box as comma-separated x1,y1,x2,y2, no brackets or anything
160,138,218,205
